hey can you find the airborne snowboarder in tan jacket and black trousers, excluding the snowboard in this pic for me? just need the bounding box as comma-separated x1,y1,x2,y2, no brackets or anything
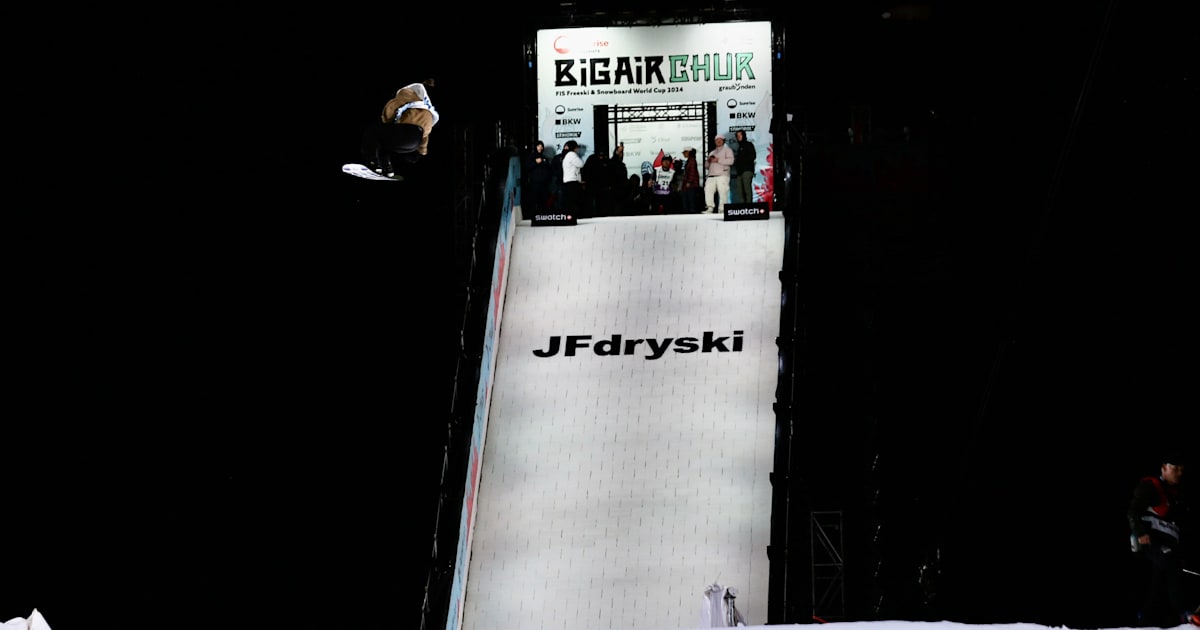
362,79,439,178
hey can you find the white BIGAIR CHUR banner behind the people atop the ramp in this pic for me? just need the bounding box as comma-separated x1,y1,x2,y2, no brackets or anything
538,22,773,200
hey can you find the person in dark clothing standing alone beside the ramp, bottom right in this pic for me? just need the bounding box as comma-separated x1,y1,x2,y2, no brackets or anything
1127,454,1194,628
